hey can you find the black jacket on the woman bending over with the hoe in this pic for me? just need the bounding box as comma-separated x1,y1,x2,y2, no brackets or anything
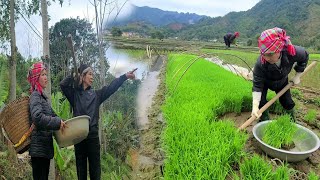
252,46,309,92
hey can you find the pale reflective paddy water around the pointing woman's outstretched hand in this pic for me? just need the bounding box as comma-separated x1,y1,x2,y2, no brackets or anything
106,47,164,129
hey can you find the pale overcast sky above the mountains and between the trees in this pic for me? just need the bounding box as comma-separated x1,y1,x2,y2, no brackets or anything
1,0,259,57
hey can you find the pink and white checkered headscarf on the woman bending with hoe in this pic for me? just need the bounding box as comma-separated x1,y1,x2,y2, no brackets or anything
258,27,296,63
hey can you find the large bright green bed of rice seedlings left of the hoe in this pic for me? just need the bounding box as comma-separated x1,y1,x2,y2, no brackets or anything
162,54,252,179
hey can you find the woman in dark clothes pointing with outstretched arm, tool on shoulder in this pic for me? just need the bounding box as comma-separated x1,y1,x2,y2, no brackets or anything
60,64,135,180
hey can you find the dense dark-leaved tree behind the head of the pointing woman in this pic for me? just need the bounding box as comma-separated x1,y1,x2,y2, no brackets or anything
49,18,99,92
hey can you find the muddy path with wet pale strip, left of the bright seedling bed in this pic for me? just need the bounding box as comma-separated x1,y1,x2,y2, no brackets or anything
129,56,166,179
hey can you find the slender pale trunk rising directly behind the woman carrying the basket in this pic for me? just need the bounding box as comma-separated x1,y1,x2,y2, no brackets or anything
41,0,56,180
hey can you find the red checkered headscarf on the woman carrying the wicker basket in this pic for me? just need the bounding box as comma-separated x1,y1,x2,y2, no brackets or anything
27,62,47,94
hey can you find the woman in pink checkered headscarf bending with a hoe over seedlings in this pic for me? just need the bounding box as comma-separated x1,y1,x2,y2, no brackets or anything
252,27,309,121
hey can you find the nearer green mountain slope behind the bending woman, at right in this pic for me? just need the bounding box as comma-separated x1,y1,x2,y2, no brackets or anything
179,0,320,49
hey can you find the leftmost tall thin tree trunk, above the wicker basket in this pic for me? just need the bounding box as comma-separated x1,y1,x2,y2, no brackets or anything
9,0,17,102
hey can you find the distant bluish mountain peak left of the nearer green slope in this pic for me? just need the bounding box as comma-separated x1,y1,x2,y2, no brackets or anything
108,5,206,27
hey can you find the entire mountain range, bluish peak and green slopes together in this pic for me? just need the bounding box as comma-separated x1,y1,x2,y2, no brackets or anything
111,0,320,50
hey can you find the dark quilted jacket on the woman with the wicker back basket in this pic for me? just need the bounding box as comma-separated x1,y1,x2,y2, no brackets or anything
29,90,61,159
